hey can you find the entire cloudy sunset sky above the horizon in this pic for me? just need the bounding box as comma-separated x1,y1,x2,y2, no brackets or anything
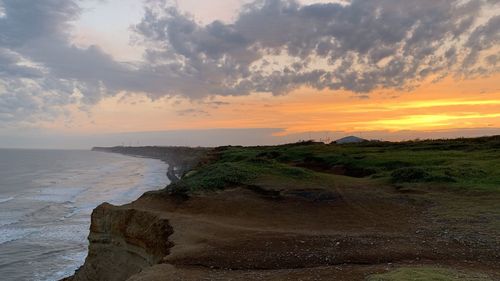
0,0,500,149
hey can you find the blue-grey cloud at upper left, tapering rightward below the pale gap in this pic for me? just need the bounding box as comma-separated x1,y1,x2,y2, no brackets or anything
0,0,167,126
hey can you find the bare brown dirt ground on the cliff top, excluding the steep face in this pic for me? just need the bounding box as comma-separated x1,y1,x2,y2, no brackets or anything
121,176,500,281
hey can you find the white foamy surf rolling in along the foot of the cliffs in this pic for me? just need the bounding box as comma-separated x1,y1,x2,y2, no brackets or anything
0,150,168,280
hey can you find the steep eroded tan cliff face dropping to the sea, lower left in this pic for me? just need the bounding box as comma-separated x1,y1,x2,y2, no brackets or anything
68,204,173,281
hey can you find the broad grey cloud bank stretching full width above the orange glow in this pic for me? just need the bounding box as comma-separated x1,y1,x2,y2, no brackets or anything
0,0,500,126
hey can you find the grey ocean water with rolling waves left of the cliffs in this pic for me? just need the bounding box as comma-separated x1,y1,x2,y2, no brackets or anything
0,149,168,281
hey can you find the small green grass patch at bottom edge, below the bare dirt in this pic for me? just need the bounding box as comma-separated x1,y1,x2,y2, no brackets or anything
367,267,492,281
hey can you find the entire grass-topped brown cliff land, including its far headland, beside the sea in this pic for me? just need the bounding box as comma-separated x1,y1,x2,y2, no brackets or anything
67,138,500,281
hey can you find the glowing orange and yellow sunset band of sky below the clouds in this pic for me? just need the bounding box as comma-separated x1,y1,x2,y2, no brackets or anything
46,74,500,137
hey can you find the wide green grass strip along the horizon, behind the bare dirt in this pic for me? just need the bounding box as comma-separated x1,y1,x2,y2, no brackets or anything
169,136,500,192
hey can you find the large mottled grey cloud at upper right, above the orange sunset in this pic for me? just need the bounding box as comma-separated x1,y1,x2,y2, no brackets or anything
136,0,500,96
